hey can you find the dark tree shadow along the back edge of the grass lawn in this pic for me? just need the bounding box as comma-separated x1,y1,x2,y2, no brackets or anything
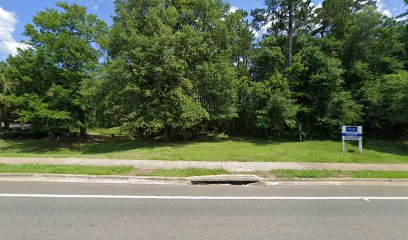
0,137,408,156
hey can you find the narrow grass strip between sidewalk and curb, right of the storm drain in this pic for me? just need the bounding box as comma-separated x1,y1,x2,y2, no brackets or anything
272,170,408,179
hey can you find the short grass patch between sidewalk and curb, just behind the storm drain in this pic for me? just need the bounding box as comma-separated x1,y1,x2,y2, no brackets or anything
138,168,229,177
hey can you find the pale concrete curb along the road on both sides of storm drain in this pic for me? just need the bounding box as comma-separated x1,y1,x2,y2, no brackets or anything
0,173,408,186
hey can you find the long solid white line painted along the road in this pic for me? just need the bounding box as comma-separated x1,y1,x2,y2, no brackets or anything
0,193,408,201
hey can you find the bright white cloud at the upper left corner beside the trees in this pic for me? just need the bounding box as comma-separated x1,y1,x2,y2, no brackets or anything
0,7,29,55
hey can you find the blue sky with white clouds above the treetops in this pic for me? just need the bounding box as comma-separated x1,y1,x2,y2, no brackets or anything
0,0,406,60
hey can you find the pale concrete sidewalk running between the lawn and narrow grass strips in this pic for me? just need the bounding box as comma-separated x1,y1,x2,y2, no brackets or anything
0,158,408,172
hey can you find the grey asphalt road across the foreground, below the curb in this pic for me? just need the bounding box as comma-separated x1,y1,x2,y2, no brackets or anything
0,182,408,240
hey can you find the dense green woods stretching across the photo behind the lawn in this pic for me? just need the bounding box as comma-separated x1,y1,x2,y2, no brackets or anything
0,0,408,140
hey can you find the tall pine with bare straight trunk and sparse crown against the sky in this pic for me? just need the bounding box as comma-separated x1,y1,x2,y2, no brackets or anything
252,0,313,66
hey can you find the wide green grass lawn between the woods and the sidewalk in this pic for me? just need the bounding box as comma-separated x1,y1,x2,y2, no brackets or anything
0,139,408,163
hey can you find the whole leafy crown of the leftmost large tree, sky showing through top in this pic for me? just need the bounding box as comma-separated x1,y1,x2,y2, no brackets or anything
8,2,107,136
